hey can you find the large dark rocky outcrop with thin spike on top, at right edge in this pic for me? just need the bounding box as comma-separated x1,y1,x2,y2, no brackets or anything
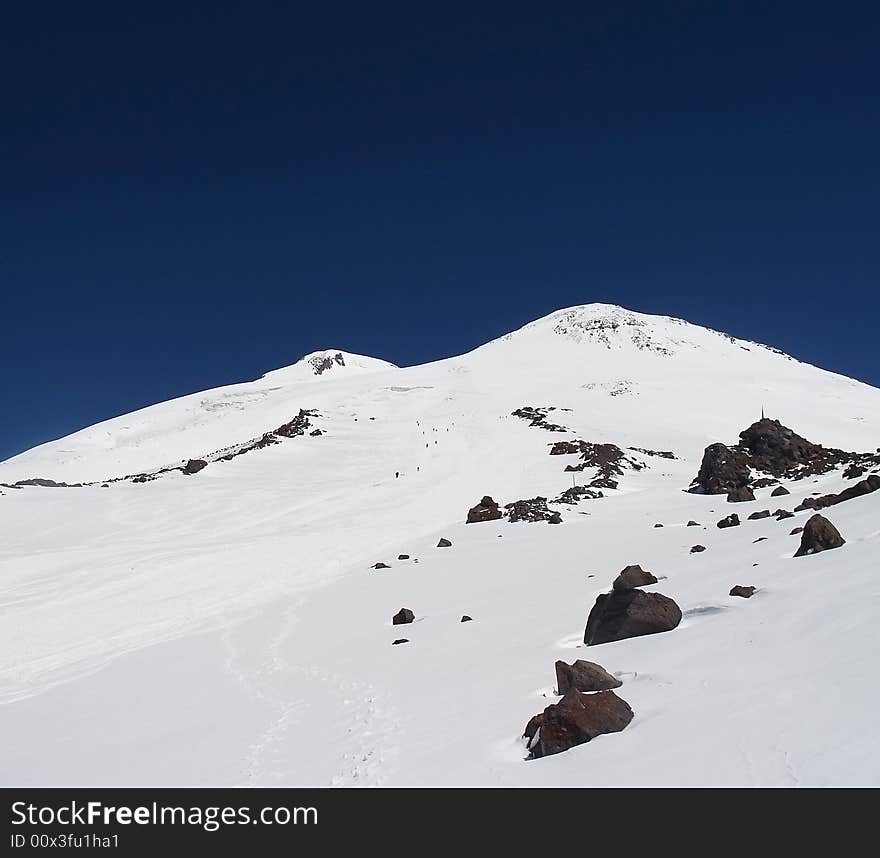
688,418,880,500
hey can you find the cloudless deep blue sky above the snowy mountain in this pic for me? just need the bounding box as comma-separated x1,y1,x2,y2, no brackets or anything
0,2,880,458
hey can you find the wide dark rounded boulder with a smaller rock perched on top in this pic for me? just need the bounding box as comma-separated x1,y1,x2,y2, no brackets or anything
584,590,681,646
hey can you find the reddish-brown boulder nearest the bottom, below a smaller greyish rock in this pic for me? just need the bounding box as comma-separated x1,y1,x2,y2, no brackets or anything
524,689,633,759
